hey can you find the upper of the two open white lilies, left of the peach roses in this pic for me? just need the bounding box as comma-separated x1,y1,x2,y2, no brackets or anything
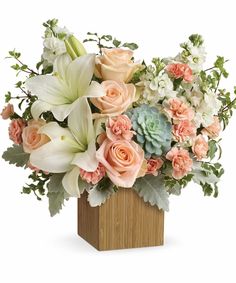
26,54,105,121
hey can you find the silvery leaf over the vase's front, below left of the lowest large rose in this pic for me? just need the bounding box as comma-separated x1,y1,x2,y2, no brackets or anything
88,178,115,207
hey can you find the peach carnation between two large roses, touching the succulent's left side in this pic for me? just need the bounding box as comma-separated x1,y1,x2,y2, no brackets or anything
106,115,134,141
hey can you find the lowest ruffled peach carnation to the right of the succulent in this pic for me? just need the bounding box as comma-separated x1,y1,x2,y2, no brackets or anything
166,147,193,179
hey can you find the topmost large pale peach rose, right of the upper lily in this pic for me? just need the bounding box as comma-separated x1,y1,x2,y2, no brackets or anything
95,48,140,83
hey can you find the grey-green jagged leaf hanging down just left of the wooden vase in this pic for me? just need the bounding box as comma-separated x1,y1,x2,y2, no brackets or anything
47,173,69,217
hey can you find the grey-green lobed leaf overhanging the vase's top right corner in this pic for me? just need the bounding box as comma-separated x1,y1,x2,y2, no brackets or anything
134,175,169,211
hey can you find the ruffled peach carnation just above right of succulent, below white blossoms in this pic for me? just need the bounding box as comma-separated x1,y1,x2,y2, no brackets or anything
165,98,194,121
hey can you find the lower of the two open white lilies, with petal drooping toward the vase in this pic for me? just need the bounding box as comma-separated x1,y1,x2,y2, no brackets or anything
30,98,98,197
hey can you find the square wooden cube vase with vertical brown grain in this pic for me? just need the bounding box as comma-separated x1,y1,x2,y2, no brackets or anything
78,189,164,250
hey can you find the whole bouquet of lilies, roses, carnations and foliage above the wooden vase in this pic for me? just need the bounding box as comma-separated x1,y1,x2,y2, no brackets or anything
1,19,236,216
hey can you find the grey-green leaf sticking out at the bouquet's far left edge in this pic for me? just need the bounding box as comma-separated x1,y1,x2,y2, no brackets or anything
2,144,30,167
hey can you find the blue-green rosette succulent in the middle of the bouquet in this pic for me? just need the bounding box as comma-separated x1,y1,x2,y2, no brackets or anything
127,104,172,158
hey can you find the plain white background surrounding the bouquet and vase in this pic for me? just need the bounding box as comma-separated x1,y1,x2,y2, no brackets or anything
0,0,236,283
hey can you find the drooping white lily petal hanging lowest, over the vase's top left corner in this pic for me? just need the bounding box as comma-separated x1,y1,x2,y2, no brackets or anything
62,166,80,197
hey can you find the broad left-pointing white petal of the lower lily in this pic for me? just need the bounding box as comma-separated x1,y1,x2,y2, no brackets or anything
30,139,75,173
